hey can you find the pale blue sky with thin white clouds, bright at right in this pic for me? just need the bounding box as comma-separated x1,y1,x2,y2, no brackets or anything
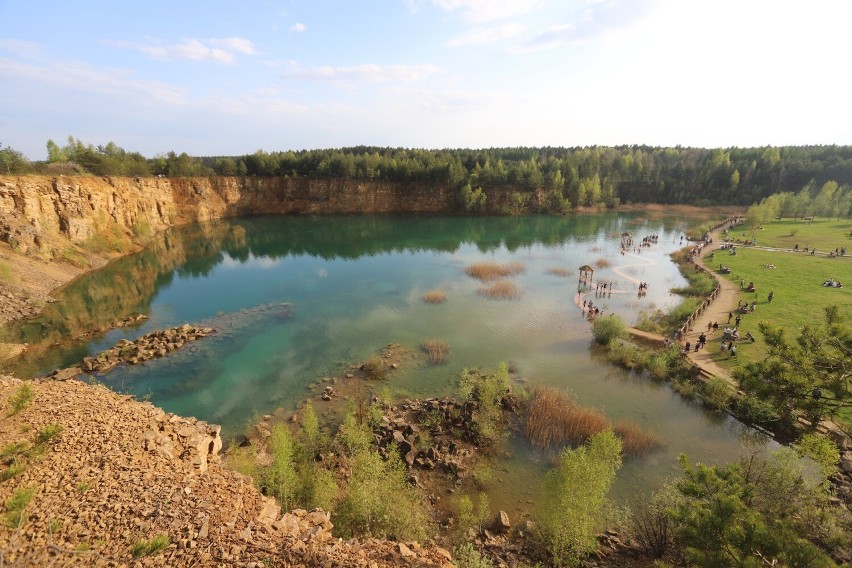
0,0,852,160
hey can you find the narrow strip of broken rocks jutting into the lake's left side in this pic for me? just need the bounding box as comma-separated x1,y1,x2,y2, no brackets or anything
80,324,216,373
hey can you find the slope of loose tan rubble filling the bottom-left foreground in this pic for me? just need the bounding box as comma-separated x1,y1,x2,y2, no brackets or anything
0,377,452,568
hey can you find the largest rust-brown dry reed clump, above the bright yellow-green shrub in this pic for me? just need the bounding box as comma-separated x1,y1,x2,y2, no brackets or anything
524,387,609,449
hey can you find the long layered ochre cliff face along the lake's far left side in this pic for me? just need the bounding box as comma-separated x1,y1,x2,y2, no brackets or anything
0,176,453,255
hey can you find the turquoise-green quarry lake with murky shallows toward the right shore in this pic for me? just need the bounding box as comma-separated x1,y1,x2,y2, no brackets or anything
3,213,762,510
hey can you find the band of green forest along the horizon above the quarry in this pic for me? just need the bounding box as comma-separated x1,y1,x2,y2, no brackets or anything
0,137,852,216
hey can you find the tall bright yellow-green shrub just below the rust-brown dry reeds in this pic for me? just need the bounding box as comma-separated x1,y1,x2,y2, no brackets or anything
536,430,621,566
